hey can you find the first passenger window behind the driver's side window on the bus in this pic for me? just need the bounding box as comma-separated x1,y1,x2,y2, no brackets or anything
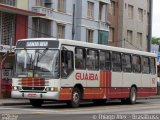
75,48,86,69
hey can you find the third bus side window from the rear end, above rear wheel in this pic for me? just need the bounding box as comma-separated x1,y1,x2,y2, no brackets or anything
132,55,141,73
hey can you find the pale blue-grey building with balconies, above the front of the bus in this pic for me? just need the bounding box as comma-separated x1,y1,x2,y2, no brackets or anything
29,0,110,45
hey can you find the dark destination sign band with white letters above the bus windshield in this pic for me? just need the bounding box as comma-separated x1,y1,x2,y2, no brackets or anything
16,40,59,48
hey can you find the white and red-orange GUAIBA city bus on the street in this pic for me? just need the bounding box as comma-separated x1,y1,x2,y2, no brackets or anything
11,38,157,108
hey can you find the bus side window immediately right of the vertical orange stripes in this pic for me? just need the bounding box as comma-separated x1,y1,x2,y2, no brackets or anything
112,52,122,72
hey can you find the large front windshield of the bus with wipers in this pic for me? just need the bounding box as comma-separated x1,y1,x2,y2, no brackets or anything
15,49,59,79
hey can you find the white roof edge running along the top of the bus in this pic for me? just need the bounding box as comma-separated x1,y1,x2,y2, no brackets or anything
18,38,157,57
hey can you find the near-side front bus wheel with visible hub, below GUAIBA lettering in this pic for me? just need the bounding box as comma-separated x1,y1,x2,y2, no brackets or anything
67,87,81,108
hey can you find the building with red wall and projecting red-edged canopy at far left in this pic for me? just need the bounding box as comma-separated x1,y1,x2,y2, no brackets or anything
0,0,45,97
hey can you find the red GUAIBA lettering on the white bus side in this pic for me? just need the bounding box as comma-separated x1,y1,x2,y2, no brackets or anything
75,73,98,80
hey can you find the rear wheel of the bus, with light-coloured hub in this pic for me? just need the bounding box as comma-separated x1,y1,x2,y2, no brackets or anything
128,87,137,104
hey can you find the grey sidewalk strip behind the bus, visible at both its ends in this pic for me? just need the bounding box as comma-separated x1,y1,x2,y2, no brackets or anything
0,95,160,106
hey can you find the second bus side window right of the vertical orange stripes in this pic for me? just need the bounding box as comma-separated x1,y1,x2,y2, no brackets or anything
122,54,132,72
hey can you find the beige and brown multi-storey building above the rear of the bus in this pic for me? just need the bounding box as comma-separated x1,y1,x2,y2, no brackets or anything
108,0,152,51
